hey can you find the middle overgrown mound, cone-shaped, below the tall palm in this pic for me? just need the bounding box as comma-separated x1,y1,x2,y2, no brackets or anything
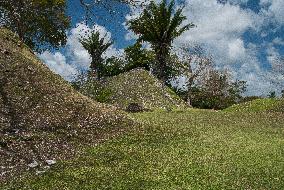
105,69,186,110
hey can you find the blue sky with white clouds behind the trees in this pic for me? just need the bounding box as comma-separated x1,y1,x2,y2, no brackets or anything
38,0,284,95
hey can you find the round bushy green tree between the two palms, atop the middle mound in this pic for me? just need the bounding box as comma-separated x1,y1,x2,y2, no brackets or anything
124,42,155,71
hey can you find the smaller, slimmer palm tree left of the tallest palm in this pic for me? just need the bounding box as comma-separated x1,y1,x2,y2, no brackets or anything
79,31,113,79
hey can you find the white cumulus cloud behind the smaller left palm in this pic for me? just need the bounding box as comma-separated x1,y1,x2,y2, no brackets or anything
39,23,123,81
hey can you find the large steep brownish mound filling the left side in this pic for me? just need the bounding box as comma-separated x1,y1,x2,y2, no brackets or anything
0,28,132,181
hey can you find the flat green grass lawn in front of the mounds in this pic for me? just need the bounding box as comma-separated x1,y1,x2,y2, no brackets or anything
4,109,284,189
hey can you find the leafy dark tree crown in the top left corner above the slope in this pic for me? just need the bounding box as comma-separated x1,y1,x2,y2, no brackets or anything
0,0,70,51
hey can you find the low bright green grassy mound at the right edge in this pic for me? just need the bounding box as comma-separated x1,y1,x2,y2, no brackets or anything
224,99,284,112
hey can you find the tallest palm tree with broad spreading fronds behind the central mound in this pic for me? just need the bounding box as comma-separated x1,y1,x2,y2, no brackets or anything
127,0,194,84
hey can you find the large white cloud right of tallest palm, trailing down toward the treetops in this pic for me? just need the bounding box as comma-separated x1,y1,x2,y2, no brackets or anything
175,0,272,95
